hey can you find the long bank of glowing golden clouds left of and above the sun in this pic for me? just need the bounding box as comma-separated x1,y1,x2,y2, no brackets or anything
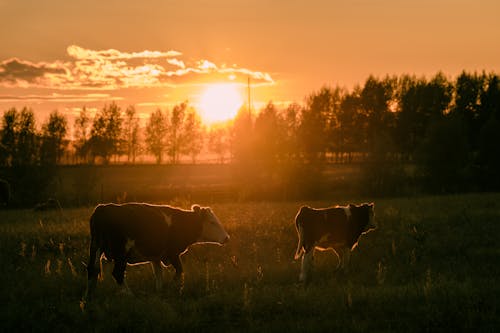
0,45,274,90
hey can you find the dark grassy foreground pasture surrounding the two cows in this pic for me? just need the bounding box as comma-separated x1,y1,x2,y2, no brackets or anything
0,194,500,332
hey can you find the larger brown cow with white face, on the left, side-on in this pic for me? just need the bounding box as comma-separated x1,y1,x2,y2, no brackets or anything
84,203,229,300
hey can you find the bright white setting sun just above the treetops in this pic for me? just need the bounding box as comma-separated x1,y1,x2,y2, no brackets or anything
198,83,243,124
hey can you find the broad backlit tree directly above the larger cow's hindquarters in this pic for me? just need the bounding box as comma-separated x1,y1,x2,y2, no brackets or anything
90,102,122,164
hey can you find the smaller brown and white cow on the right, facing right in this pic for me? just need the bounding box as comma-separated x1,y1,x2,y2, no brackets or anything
295,203,376,282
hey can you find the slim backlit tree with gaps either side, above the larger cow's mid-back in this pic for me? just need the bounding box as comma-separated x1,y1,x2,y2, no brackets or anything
146,109,168,164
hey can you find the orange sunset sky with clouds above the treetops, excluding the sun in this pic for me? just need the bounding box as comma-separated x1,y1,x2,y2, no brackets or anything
0,0,500,120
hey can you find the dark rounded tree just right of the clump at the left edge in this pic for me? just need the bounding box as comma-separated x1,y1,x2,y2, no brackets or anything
40,110,68,165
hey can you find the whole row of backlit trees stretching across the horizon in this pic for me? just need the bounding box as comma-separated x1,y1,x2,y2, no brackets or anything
0,71,500,197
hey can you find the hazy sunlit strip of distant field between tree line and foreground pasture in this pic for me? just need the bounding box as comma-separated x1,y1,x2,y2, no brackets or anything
52,164,359,206
